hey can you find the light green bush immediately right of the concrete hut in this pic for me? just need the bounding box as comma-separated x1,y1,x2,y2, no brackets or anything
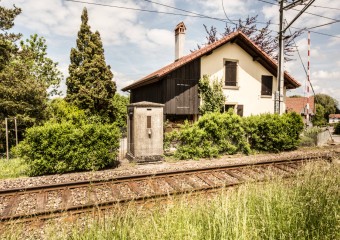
165,113,250,159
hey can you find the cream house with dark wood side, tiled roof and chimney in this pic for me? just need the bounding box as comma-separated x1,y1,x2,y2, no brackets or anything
122,22,300,121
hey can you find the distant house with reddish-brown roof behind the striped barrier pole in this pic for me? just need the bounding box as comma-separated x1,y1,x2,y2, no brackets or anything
286,96,315,125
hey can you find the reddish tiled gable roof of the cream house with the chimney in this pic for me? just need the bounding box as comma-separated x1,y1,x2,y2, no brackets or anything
122,31,300,91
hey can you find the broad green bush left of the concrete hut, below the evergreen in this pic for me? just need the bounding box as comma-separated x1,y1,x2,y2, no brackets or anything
16,122,120,176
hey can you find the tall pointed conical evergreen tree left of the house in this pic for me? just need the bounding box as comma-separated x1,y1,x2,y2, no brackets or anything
66,8,116,121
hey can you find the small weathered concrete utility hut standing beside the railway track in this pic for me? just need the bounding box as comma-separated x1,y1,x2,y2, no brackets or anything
127,102,164,163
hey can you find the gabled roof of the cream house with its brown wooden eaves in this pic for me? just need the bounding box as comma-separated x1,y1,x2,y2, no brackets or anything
122,31,300,91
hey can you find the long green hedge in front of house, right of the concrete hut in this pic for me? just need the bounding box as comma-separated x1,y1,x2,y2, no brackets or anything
164,112,304,159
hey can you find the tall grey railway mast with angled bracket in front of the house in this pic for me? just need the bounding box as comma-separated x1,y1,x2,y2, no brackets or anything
274,0,315,115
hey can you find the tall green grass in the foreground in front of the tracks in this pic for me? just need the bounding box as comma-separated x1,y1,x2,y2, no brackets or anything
3,164,340,240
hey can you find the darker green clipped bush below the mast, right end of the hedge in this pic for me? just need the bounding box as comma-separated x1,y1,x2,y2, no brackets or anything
245,113,304,152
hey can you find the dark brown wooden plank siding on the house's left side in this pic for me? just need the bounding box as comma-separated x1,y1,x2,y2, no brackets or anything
130,58,201,115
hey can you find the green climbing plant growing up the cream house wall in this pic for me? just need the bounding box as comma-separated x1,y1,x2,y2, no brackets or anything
198,75,226,115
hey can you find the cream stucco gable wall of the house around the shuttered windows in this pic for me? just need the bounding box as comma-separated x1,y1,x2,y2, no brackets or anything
201,43,286,116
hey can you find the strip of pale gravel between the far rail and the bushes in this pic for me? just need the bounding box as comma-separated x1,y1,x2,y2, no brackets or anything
0,145,340,190
